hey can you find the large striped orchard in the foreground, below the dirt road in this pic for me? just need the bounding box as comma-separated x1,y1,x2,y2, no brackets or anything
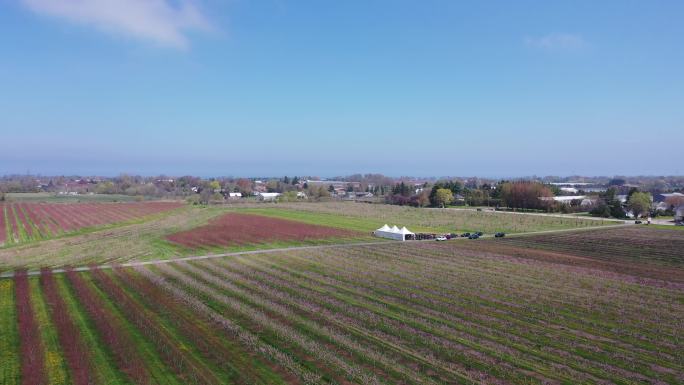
0,241,684,384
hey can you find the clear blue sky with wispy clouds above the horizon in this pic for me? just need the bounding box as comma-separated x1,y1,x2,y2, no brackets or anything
0,0,684,177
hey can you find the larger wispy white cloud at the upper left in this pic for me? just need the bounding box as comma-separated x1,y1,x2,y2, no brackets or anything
21,0,211,48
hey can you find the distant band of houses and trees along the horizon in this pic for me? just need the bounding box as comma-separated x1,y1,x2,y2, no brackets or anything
0,174,684,224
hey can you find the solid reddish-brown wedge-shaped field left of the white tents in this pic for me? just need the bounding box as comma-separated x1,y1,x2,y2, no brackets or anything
167,213,358,248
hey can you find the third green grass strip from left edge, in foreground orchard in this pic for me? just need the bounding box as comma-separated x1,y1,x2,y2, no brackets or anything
54,274,131,385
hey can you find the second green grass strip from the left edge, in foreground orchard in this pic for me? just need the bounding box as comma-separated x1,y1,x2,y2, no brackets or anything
29,278,71,385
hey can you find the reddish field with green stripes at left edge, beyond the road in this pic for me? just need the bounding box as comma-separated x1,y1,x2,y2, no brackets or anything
0,202,183,245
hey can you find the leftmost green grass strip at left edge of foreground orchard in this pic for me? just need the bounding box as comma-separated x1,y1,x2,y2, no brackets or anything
0,279,21,385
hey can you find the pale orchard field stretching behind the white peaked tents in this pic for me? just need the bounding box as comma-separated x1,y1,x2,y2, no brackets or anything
242,202,618,234
